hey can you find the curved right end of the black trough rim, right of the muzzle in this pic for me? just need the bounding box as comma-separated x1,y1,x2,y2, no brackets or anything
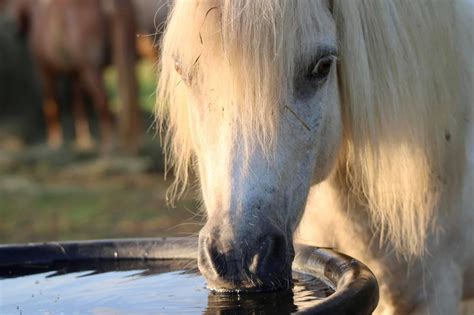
293,244,379,315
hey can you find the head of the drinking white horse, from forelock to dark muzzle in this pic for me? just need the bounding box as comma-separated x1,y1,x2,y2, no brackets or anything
160,1,342,290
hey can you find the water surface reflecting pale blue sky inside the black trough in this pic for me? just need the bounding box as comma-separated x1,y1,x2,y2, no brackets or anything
0,260,334,315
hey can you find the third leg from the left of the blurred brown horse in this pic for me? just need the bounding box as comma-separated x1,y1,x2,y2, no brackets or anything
82,68,114,153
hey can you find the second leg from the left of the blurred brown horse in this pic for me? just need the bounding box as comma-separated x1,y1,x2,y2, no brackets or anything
73,76,94,151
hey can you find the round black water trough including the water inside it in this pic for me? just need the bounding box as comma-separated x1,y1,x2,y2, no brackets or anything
0,238,379,314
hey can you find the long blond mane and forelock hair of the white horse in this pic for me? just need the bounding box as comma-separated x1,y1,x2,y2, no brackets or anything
156,0,473,255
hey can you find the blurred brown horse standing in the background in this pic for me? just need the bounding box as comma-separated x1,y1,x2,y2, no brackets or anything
13,0,139,151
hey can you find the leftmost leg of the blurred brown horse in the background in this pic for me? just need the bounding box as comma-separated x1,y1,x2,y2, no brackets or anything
40,68,63,149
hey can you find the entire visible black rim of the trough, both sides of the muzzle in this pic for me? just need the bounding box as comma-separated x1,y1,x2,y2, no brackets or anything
0,237,379,315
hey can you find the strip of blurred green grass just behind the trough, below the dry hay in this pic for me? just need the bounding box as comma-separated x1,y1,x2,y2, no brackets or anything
0,175,200,243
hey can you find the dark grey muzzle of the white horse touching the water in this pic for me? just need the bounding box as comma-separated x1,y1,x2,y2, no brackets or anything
198,222,294,292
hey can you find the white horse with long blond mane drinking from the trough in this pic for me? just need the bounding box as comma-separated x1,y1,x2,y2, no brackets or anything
157,0,474,314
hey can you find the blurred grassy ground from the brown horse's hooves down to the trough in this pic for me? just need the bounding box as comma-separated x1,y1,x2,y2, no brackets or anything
0,149,202,243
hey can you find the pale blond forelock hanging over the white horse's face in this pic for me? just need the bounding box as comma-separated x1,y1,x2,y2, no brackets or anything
157,0,328,195
